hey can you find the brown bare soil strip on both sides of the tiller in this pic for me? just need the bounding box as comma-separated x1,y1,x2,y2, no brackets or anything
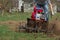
0,20,60,35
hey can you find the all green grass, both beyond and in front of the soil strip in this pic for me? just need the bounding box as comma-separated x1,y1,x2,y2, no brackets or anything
0,12,60,40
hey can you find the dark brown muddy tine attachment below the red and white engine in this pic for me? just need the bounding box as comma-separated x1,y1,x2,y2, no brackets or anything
19,18,48,33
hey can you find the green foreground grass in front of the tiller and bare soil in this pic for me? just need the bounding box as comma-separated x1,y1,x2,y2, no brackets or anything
0,25,56,40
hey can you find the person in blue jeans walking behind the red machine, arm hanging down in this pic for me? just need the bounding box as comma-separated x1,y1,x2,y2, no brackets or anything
34,0,54,21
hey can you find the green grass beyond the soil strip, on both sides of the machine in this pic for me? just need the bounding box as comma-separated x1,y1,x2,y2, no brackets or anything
0,12,60,21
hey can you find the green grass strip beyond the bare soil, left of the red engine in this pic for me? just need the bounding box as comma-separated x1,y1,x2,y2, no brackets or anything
0,12,31,21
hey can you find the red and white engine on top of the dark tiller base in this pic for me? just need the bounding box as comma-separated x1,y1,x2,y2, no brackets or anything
31,6,45,20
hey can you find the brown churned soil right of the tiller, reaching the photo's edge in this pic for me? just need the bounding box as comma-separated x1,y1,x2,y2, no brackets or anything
48,20,60,35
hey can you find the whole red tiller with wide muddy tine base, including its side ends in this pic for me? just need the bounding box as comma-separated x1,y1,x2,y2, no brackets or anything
19,6,55,33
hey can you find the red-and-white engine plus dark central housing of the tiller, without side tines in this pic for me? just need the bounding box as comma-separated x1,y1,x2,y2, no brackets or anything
26,6,48,32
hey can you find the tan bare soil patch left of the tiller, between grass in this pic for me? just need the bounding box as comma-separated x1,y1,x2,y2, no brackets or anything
0,21,26,31
